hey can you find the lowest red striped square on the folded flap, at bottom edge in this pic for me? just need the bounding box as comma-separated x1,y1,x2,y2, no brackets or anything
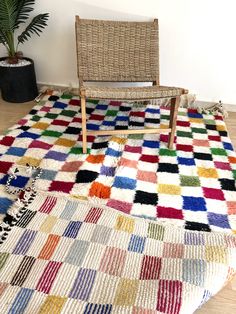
157,280,183,314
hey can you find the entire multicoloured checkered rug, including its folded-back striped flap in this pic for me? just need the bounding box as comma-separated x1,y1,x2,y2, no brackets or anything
0,95,236,314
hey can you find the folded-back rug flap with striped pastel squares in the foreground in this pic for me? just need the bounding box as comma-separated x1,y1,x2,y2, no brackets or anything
0,192,236,314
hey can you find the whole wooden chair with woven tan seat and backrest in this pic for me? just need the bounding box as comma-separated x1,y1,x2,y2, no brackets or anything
75,16,187,153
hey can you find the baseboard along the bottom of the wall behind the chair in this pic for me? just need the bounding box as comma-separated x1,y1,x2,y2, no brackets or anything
38,82,236,112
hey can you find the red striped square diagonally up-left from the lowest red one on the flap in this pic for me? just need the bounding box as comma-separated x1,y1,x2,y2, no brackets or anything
139,255,161,280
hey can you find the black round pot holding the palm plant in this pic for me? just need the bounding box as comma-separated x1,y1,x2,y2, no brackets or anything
0,58,38,103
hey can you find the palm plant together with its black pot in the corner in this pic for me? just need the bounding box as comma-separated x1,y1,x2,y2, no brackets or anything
0,0,49,102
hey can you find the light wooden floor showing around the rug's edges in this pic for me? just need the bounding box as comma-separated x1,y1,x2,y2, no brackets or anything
0,99,236,314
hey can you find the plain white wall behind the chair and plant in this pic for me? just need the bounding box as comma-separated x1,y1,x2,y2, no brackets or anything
0,0,236,105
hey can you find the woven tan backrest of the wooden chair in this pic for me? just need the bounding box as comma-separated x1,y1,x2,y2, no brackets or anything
75,16,159,85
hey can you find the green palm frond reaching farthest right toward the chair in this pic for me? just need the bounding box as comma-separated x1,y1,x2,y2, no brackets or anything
18,13,49,44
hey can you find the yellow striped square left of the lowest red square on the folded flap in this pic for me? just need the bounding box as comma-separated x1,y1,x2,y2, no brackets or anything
114,279,139,306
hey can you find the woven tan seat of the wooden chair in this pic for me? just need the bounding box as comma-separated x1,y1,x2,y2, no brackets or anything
80,85,183,100
